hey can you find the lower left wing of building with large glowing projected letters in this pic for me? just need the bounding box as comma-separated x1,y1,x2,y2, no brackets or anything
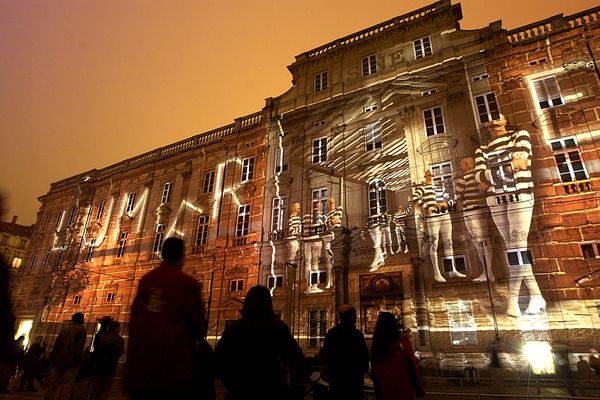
13,113,266,336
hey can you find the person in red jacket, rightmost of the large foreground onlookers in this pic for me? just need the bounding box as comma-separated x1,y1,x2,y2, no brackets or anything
371,312,425,400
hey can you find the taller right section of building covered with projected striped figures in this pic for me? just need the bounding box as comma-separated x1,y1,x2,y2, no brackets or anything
261,1,600,370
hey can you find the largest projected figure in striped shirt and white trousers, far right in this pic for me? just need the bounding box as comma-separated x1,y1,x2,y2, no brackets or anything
475,117,546,317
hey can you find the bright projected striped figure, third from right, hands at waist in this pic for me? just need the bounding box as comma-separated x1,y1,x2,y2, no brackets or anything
411,171,465,282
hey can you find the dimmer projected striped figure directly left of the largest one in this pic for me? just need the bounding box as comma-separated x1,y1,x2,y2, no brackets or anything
454,157,494,282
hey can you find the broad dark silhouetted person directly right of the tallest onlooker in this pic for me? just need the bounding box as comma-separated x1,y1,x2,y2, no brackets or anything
215,286,305,400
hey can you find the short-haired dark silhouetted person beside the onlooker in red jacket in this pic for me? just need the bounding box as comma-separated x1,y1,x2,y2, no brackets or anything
321,304,369,400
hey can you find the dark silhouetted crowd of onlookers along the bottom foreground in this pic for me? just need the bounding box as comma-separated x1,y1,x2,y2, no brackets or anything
0,238,600,400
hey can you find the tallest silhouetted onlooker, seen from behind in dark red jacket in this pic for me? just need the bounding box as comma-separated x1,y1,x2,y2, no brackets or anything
125,237,207,400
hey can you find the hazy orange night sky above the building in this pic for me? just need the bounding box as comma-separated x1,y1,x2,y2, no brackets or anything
0,0,598,224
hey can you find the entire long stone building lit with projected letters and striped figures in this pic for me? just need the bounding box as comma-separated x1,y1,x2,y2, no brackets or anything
10,0,600,371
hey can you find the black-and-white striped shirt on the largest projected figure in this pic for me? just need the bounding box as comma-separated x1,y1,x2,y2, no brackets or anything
475,131,533,197
